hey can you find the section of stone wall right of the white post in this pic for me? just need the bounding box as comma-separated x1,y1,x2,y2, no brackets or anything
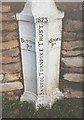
57,3,84,97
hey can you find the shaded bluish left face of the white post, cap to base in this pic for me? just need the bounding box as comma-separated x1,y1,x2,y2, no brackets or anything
16,2,37,104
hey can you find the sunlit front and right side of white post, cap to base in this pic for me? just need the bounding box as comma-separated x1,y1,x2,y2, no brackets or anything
32,0,64,108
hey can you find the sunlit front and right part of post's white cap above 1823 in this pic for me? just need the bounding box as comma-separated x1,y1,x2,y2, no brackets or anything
30,0,64,18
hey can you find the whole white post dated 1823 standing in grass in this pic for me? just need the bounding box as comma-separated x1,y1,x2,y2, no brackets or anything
17,0,64,108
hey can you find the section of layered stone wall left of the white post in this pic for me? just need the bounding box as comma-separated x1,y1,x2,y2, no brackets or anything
0,3,23,99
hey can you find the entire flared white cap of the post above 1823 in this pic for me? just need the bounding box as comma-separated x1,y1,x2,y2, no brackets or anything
16,0,64,22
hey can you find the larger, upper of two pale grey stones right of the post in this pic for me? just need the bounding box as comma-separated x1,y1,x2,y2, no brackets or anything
62,57,82,67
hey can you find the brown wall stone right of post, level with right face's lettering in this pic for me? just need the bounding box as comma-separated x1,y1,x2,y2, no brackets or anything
62,40,82,50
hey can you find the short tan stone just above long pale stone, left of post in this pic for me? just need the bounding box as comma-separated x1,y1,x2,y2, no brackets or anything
5,73,20,82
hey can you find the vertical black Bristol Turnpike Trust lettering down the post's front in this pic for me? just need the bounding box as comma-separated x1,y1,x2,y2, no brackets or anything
38,24,45,95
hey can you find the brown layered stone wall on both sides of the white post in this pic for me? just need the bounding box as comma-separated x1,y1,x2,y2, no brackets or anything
0,3,84,99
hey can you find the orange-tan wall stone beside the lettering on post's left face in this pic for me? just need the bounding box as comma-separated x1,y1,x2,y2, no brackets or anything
0,40,19,50
